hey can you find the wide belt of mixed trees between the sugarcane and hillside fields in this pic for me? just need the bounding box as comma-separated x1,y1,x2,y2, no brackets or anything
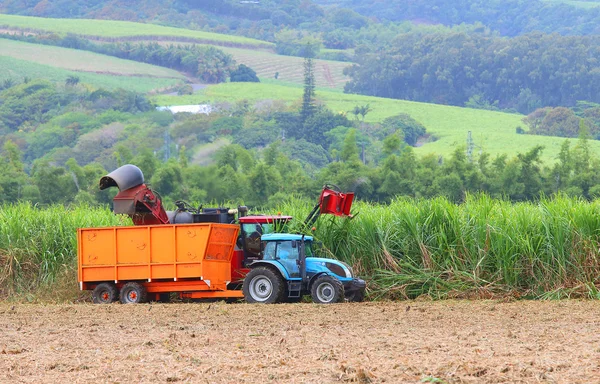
0,79,600,210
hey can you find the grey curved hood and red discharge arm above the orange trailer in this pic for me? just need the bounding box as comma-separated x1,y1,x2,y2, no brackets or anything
100,164,169,225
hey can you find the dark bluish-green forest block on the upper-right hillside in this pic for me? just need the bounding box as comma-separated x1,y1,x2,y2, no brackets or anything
345,32,600,113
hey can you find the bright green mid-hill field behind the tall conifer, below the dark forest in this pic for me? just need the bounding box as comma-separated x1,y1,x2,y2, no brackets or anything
153,83,600,163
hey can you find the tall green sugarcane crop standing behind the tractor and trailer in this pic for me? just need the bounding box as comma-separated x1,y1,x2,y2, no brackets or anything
0,195,600,300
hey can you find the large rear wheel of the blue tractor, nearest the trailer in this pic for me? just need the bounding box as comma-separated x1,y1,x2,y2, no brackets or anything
242,267,286,304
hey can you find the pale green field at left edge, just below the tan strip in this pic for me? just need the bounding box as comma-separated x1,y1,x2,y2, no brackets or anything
0,56,179,93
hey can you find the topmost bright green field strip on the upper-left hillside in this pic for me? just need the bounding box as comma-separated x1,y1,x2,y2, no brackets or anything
0,14,273,48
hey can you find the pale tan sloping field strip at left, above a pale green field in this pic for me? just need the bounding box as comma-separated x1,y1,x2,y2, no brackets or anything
0,38,184,79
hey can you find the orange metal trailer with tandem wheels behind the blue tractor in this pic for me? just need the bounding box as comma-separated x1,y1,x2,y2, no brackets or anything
77,223,243,303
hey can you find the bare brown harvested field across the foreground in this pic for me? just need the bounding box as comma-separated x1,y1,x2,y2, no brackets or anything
0,301,600,383
